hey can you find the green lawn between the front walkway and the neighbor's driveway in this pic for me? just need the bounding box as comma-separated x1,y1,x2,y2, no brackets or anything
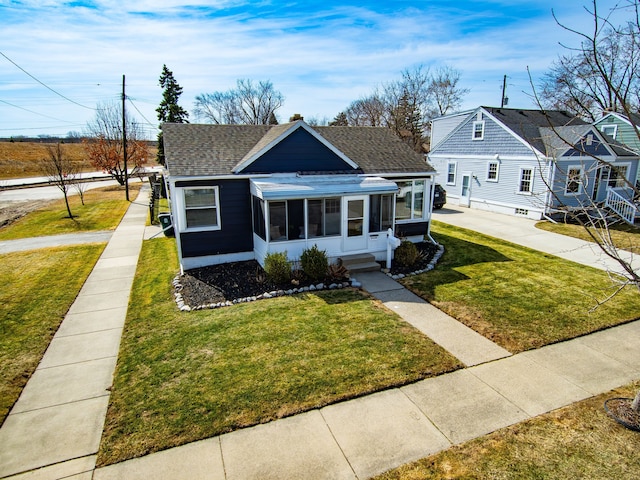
403,222,640,353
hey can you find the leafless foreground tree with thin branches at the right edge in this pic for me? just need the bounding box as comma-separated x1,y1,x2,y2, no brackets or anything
534,0,640,420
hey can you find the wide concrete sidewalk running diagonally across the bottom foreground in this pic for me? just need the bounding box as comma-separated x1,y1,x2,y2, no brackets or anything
93,321,640,480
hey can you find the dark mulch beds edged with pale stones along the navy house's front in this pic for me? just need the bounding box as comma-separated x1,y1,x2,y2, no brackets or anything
177,242,438,307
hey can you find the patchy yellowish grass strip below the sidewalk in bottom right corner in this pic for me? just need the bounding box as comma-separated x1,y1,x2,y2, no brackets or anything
376,383,640,480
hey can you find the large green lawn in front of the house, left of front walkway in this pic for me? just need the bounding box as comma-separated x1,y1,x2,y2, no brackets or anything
98,238,461,465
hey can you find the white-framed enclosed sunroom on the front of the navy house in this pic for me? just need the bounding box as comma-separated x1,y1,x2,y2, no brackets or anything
250,174,430,264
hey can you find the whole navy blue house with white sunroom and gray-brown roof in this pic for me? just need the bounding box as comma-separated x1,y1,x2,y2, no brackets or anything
162,120,435,270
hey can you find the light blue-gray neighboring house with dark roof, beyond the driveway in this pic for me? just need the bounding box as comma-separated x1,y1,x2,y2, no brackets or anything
428,107,639,219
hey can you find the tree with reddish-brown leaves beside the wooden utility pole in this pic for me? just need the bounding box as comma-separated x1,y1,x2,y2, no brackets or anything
85,103,149,185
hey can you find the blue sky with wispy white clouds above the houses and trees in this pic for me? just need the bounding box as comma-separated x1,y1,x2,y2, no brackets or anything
0,0,616,138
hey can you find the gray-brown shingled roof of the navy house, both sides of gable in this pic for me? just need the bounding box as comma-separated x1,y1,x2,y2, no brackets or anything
162,123,434,177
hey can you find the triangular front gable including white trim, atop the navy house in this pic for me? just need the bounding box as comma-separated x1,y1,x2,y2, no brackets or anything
233,120,360,174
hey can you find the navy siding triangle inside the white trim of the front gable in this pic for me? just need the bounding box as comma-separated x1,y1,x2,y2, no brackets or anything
242,128,353,173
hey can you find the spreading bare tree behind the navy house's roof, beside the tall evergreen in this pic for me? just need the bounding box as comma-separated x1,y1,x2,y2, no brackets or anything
194,79,284,125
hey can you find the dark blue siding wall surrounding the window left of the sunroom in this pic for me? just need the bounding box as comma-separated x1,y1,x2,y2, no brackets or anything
176,179,253,258
